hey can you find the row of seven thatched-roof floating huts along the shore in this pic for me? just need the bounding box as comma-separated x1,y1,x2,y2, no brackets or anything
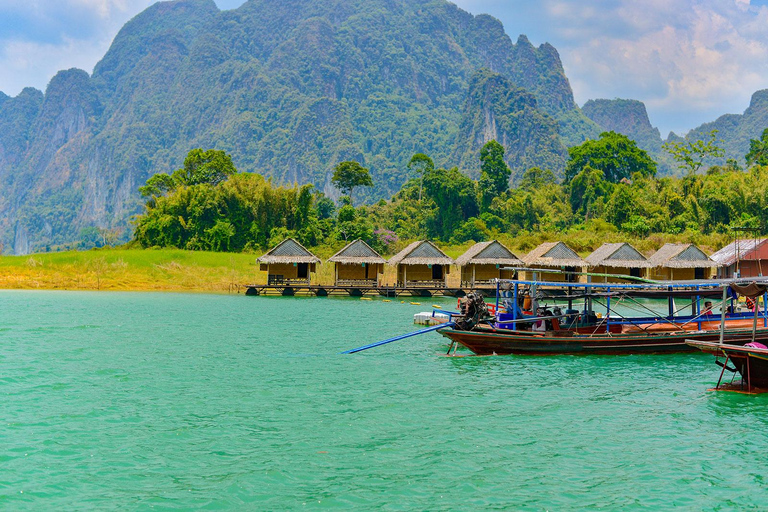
250,238,744,296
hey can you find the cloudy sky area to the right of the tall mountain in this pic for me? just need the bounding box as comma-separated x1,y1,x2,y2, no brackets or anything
455,0,768,133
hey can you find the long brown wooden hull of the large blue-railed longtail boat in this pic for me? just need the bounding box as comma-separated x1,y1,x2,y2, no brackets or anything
438,328,768,355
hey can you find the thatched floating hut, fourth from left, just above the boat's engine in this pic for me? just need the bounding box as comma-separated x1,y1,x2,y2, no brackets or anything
456,240,523,288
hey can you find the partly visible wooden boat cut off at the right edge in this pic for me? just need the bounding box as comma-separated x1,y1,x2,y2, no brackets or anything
686,280,768,393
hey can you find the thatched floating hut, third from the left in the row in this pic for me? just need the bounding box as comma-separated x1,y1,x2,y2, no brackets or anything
389,240,453,288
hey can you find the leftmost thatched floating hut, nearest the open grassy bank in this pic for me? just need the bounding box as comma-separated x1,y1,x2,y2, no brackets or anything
256,238,320,286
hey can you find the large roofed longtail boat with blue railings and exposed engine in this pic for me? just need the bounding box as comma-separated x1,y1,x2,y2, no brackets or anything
438,274,768,355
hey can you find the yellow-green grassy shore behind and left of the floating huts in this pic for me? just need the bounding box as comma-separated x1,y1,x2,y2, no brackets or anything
0,233,728,293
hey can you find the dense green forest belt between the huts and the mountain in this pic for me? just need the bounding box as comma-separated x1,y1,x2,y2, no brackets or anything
129,130,768,254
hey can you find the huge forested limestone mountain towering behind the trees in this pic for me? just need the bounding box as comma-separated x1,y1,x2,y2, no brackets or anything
0,0,599,254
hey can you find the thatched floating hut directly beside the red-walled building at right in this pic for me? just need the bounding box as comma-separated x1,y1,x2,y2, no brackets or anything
648,244,718,281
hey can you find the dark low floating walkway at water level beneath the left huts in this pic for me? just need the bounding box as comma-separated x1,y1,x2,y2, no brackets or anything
242,283,496,297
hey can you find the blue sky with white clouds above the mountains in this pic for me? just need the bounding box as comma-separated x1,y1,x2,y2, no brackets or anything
0,0,768,137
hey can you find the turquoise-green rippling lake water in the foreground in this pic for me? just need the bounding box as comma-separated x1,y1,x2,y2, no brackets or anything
0,292,768,510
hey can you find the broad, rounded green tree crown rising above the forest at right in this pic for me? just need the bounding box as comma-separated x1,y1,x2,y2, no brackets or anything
565,132,656,183
